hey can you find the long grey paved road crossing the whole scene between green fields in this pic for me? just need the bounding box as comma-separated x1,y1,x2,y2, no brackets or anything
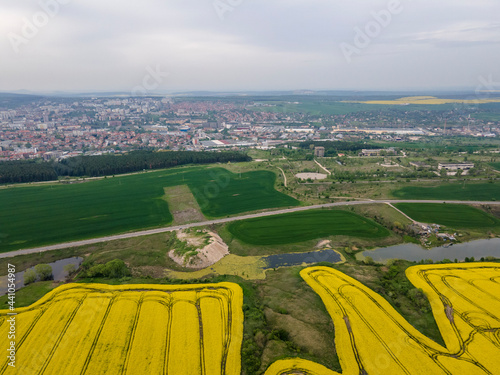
0,200,500,258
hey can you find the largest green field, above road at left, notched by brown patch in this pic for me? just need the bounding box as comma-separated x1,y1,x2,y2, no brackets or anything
0,167,299,252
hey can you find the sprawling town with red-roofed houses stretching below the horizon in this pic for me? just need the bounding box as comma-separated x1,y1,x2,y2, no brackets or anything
0,96,500,160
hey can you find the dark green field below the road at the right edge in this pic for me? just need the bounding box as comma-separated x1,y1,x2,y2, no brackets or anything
395,203,500,229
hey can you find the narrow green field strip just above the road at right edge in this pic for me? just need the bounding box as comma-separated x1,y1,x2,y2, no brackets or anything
392,181,500,201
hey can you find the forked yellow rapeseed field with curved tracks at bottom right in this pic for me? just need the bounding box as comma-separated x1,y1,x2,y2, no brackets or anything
266,263,500,375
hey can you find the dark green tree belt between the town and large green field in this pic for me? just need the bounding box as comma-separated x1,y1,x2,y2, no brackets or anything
0,151,251,183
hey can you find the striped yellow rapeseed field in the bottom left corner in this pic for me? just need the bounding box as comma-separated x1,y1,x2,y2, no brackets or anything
0,283,243,375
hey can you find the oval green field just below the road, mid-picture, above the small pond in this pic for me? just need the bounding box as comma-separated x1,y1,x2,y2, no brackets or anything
228,210,390,245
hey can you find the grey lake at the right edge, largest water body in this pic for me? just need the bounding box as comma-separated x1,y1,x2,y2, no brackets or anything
363,238,500,262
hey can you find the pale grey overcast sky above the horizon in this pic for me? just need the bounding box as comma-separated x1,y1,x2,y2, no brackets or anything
0,0,500,92
